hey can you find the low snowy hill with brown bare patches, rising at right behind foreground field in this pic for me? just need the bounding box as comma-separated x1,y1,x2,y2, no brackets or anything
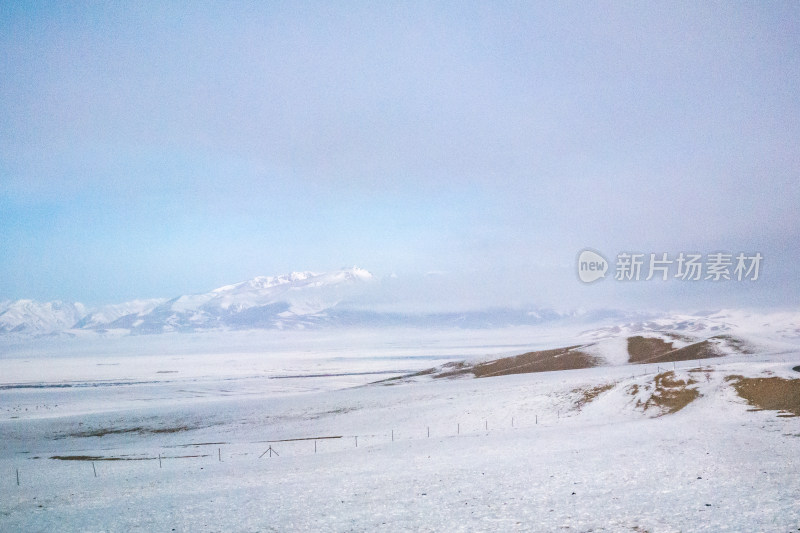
389,310,800,382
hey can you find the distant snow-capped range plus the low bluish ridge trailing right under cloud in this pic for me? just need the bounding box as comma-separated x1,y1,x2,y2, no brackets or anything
0,267,588,335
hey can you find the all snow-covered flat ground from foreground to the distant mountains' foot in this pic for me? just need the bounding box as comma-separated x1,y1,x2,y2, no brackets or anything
0,318,800,532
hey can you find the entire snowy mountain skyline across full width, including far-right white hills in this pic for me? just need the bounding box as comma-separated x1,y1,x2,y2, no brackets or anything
0,267,800,342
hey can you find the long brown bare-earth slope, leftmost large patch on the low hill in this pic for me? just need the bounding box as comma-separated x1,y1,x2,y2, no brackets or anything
434,346,600,378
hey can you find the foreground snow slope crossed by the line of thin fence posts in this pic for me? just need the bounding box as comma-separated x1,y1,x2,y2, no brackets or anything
0,356,800,532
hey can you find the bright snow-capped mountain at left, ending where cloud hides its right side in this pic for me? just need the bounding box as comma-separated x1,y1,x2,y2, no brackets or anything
0,267,375,335
